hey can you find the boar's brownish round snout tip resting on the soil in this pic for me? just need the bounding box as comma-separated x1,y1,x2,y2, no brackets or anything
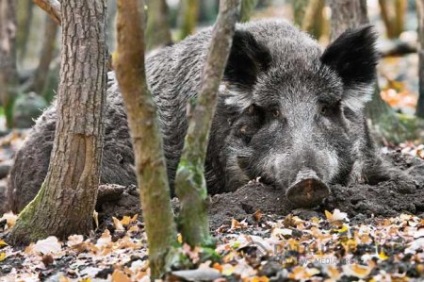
286,168,330,208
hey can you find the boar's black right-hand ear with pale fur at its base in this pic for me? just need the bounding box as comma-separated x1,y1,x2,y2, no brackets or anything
321,25,378,108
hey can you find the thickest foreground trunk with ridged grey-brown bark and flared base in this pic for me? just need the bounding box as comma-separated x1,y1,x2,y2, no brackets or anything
9,0,106,244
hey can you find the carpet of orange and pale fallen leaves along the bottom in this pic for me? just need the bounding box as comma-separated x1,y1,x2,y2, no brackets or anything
0,209,424,282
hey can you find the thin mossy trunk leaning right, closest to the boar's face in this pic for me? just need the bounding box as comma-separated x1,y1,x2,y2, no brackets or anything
175,0,240,246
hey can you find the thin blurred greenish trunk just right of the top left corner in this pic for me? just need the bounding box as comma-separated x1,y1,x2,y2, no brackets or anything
16,0,34,65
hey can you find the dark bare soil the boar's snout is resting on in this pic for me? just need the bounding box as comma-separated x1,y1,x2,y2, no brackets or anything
97,152,424,230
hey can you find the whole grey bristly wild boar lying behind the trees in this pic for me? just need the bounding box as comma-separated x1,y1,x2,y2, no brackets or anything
7,20,414,212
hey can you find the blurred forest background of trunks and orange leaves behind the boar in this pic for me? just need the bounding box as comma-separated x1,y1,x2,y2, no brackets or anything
0,0,424,143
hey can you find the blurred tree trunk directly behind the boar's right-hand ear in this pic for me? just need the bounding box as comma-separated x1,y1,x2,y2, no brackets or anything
329,0,408,143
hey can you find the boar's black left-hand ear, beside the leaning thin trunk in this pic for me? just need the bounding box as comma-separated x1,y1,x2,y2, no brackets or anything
224,30,271,89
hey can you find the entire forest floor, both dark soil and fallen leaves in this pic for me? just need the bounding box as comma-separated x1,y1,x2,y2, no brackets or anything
0,132,424,281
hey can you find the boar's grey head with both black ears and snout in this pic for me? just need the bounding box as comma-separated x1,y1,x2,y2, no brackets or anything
206,26,377,206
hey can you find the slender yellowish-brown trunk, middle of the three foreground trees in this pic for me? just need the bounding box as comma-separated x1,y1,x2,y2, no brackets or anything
115,0,177,279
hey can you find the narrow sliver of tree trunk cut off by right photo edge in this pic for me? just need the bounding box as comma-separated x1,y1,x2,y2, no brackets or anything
416,0,424,118
